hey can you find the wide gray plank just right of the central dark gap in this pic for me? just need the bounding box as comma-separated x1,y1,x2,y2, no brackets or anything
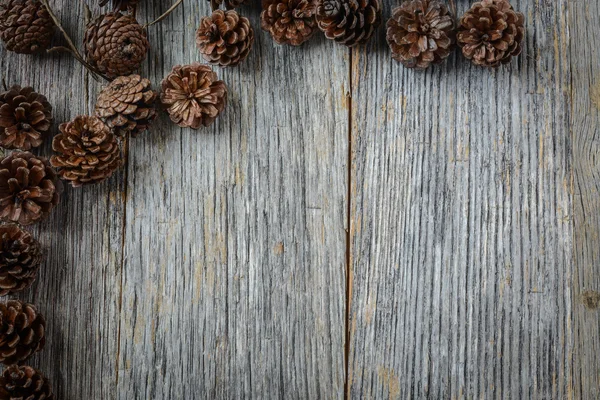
349,0,576,399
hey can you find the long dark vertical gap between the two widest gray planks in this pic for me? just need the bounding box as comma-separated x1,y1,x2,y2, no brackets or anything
344,48,352,400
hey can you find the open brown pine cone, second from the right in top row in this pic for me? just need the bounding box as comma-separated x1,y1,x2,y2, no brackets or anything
386,0,454,69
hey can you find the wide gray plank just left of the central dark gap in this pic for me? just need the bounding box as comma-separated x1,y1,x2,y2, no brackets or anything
117,0,349,399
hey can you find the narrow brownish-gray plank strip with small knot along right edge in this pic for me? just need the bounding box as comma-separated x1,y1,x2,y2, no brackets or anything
568,0,600,399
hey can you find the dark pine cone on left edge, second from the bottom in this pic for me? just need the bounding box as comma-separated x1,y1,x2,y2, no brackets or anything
0,300,46,365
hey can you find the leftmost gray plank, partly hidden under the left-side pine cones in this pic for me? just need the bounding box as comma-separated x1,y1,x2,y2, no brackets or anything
0,0,125,399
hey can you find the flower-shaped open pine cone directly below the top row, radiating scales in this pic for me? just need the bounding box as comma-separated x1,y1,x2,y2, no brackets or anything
160,64,227,129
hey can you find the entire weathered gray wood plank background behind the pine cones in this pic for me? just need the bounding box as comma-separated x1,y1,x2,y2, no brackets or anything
0,0,600,399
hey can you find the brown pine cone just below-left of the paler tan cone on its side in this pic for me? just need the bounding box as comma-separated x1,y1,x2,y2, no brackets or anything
50,115,121,187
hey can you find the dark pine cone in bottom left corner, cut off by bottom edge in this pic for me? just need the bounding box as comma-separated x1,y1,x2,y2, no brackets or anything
0,365,54,400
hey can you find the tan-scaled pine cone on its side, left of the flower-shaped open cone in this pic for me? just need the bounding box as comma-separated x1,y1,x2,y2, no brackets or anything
96,75,158,136
